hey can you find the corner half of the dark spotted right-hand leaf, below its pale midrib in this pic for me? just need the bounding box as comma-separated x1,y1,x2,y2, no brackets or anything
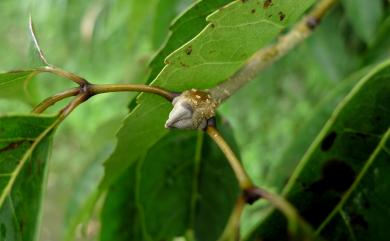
318,129,390,241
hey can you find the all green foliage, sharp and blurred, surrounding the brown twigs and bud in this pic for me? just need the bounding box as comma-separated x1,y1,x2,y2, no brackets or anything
0,0,390,241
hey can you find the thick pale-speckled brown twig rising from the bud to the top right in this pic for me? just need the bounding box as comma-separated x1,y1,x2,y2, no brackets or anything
210,0,337,103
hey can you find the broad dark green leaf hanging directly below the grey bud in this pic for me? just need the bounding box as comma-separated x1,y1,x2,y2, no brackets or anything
101,120,239,241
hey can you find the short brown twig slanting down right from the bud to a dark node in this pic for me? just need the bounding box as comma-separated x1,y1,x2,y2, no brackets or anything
206,125,253,190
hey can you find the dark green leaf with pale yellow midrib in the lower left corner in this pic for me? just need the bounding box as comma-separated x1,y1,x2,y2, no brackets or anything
0,116,56,241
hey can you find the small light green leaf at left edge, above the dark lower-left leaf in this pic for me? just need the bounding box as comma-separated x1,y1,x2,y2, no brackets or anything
0,70,38,104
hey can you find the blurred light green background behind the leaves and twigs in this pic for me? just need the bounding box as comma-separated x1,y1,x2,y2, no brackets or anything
0,0,390,241
